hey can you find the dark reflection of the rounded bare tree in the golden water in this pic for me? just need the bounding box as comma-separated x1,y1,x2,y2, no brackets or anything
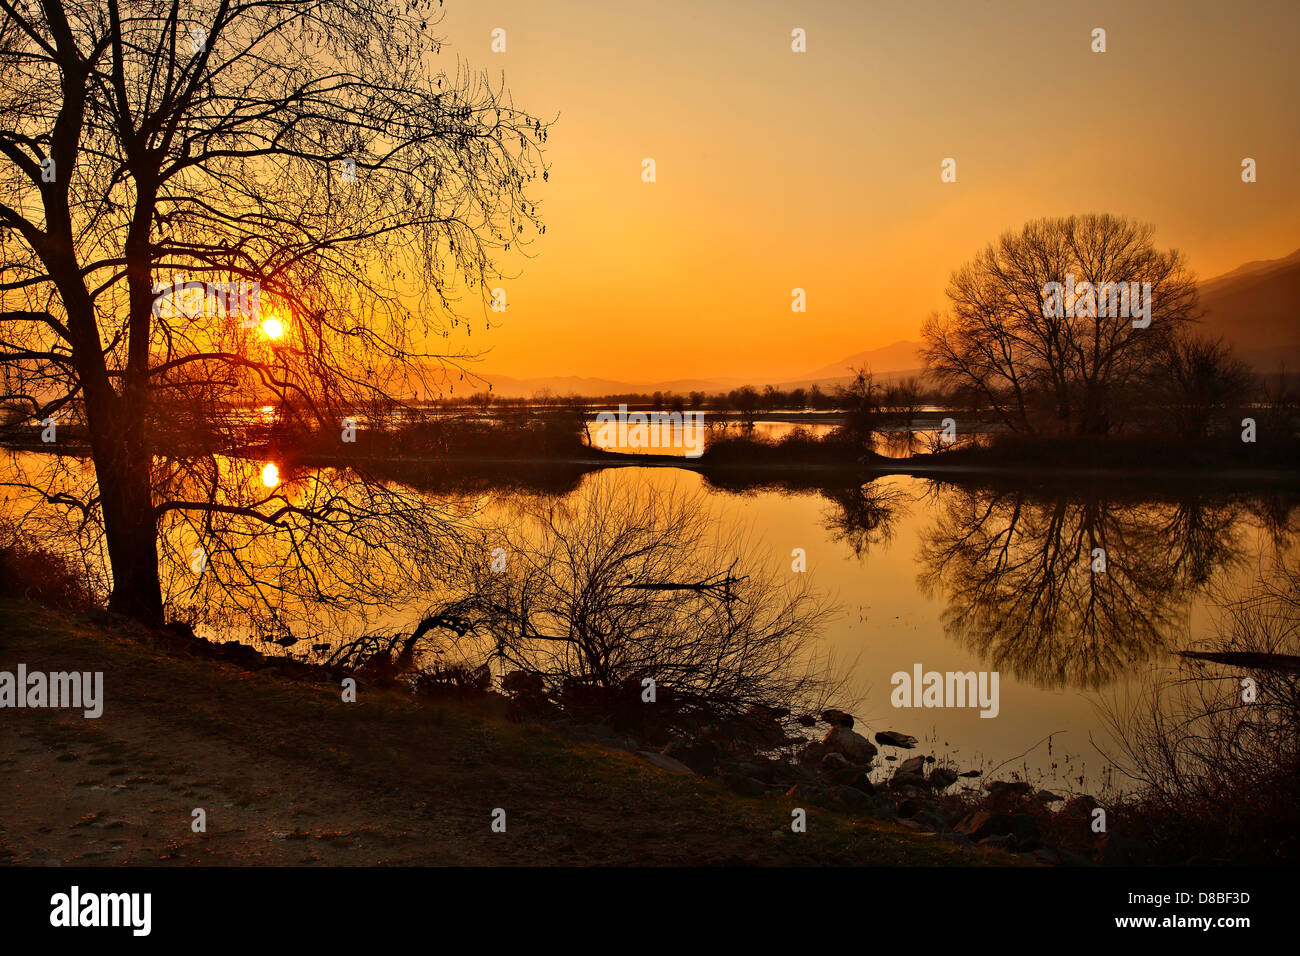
918,485,1247,689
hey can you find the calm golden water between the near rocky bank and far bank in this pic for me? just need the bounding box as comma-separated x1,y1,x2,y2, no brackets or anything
7,455,1300,792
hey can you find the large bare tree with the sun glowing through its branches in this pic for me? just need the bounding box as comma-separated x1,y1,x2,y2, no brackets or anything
0,0,546,620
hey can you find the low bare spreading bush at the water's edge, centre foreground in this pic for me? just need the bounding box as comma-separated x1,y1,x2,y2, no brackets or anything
384,479,839,717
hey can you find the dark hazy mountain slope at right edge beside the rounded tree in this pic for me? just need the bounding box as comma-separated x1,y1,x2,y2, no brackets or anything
1200,250,1300,372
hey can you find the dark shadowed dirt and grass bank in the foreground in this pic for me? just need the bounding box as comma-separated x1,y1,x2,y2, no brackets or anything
0,601,1015,865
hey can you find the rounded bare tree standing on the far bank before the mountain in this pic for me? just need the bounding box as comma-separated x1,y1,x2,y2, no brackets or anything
922,215,1197,434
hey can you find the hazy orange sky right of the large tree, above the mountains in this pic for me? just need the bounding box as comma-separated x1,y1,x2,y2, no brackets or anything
441,0,1300,381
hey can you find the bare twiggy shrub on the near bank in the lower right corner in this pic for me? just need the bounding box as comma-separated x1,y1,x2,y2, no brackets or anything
1102,555,1300,864
